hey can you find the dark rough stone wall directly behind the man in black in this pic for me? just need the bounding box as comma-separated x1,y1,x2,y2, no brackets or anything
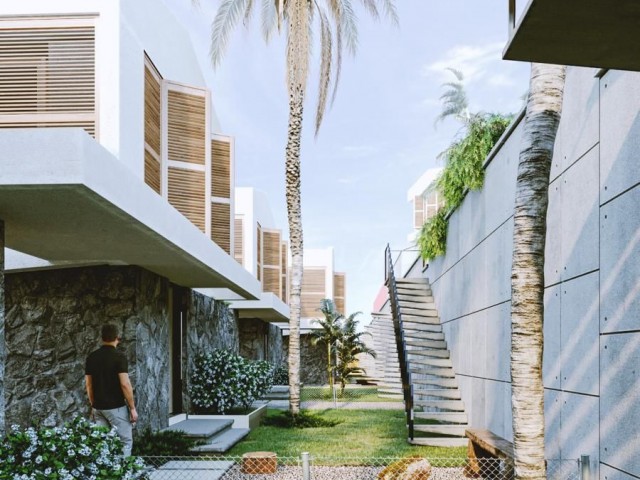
5,266,169,428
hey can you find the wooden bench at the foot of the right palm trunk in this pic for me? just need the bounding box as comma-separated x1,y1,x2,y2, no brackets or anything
464,429,514,480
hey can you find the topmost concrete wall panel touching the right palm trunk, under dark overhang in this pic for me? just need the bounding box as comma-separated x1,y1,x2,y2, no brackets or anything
551,67,600,179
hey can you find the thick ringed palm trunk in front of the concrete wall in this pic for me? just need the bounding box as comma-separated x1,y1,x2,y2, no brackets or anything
511,64,566,480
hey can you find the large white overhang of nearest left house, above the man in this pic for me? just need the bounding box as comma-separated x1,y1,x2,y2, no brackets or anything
0,128,261,299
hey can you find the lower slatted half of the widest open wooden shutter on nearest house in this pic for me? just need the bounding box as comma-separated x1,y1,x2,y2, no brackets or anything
168,167,206,232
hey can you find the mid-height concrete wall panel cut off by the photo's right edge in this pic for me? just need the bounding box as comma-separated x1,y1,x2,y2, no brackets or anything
600,187,640,332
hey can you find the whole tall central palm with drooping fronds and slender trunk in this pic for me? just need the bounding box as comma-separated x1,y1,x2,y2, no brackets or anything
202,0,397,415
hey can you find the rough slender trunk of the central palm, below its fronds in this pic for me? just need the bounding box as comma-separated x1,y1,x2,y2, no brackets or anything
285,85,304,415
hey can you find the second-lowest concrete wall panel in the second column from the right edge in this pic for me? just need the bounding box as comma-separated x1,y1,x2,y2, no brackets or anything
559,272,600,395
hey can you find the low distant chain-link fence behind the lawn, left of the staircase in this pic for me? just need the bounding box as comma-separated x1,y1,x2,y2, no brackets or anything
300,384,403,410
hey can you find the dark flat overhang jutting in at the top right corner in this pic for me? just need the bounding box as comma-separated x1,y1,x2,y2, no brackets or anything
503,0,640,70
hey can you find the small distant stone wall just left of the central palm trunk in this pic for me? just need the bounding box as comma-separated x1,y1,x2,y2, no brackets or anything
239,318,283,365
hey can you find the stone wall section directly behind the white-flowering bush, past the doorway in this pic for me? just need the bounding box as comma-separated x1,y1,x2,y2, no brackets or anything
182,291,240,411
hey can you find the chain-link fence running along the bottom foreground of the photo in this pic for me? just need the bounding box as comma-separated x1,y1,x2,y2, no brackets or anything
140,452,589,480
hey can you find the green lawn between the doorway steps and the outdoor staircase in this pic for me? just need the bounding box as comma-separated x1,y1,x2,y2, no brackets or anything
226,409,466,463
